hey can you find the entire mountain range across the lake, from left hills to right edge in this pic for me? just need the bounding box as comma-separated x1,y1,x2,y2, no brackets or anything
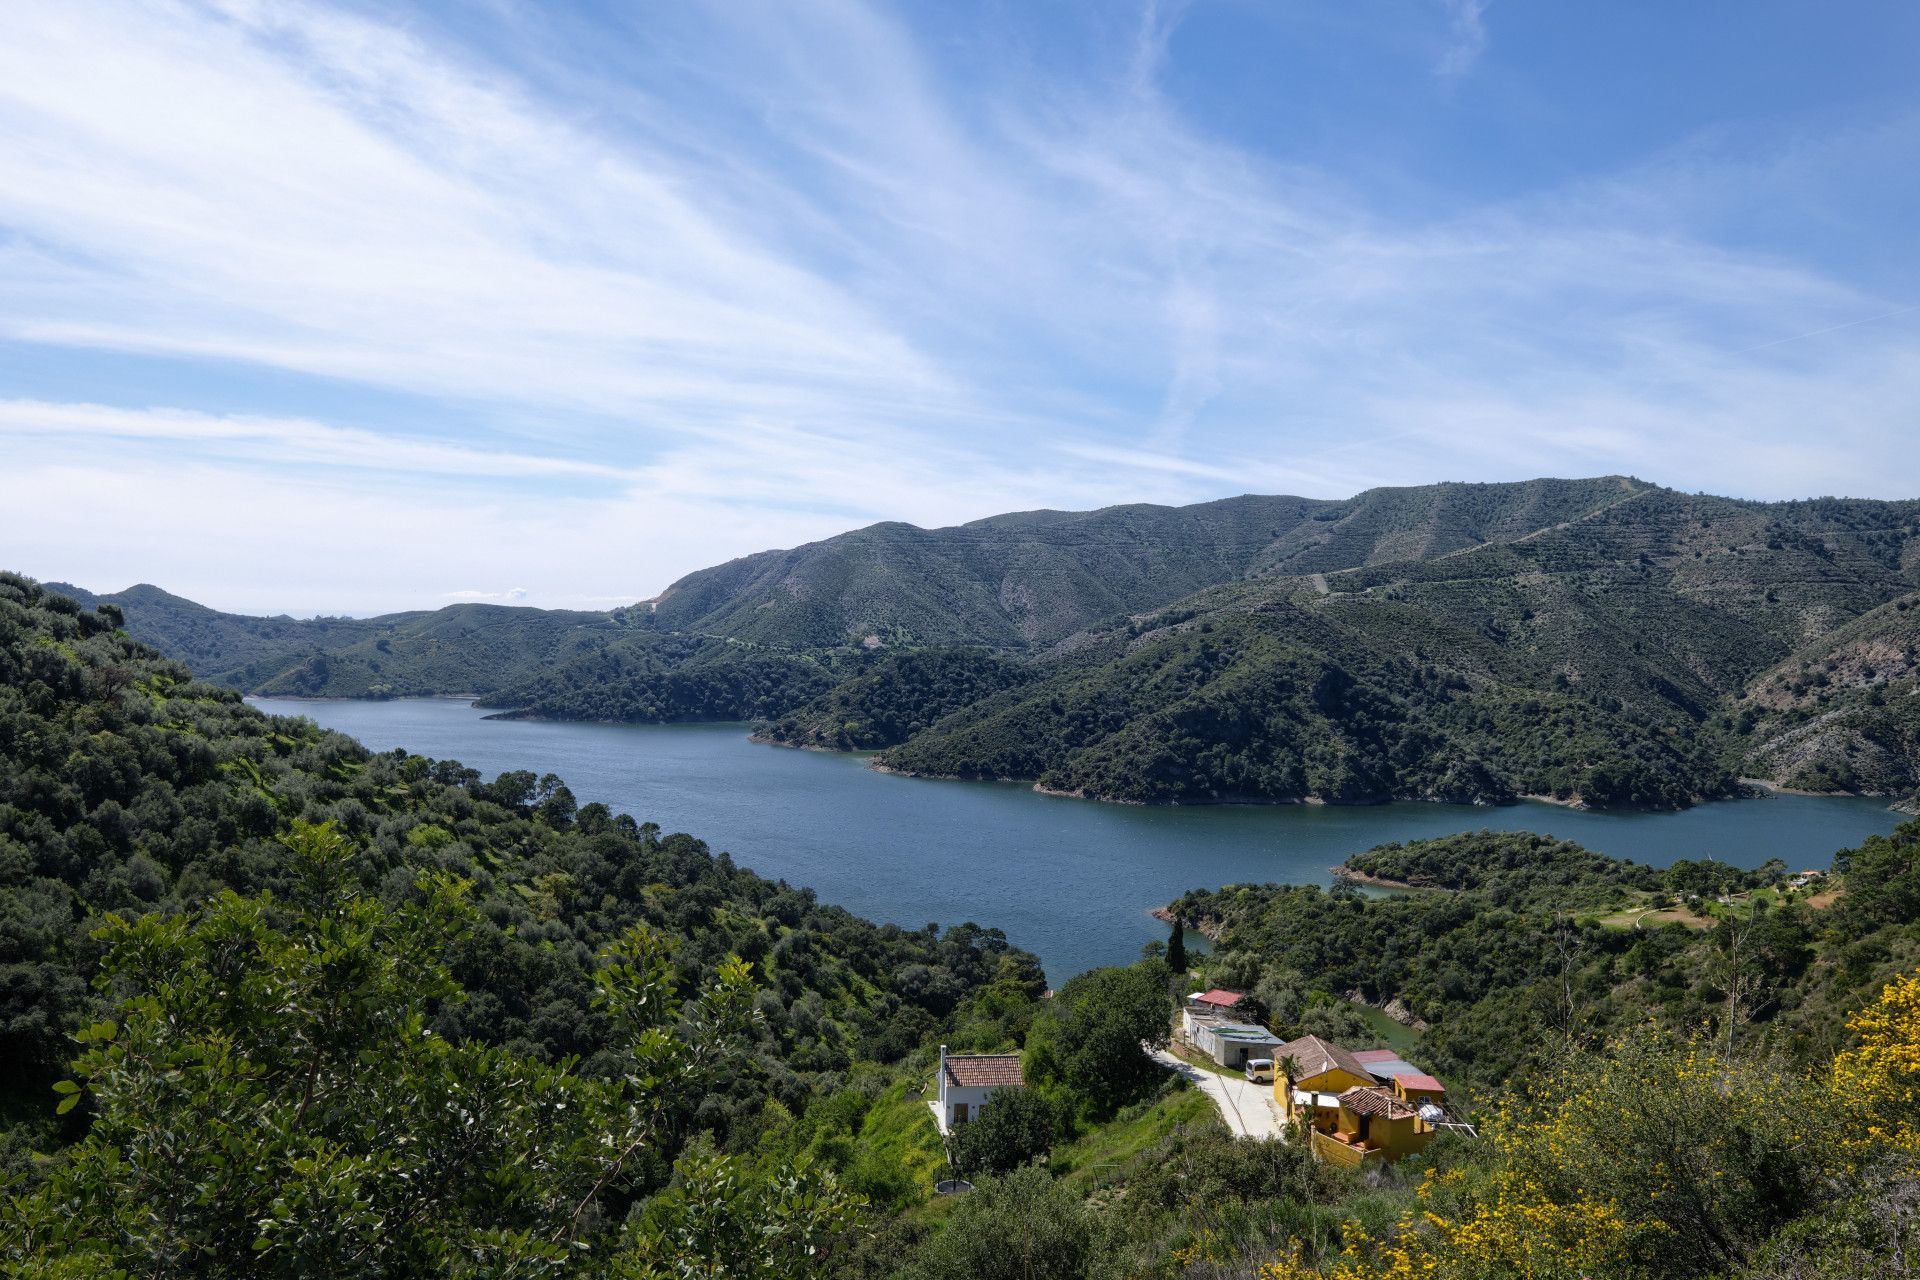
37,476,1920,808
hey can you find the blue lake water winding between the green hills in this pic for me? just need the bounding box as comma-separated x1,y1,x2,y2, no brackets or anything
253,699,1901,983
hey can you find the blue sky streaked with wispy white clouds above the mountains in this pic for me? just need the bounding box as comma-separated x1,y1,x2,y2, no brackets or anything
0,0,1920,616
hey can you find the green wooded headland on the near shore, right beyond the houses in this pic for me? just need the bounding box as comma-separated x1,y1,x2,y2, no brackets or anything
1173,823,1881,1088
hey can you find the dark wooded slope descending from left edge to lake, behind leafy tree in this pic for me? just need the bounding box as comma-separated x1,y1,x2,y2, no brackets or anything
0,574,1044,1205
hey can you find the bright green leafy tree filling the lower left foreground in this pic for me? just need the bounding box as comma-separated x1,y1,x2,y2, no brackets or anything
0,823,856,1278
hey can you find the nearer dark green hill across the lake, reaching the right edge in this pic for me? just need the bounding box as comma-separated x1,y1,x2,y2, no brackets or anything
881,489,1920,806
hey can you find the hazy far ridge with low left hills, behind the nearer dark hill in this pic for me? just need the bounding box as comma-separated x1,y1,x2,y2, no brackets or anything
48,478,1645,690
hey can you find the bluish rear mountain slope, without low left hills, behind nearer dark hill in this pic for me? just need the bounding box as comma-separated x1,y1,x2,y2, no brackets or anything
651,476,1647,647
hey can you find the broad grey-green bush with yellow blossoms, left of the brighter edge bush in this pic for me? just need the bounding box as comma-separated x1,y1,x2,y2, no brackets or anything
1260,1028,1827,1280
